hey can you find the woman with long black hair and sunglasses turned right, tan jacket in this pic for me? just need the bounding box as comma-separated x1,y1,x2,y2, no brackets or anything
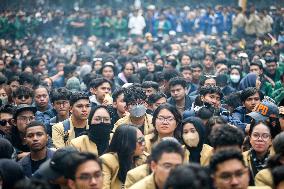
100,125,146,189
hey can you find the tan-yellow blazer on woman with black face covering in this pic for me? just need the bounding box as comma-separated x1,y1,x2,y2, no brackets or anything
70,135,98,155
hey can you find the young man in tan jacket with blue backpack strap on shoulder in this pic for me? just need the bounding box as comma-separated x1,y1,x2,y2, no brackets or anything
52,92,91,148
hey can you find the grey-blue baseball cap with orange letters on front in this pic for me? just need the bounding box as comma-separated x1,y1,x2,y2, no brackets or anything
248,100,279,121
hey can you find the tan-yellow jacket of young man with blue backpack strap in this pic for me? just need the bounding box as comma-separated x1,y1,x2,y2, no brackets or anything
52,116,89,148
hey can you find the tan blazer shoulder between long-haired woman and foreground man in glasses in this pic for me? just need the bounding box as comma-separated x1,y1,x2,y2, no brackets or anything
125,164,150,189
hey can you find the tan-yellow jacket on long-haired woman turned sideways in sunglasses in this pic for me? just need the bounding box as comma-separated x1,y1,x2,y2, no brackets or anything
100,153,147,189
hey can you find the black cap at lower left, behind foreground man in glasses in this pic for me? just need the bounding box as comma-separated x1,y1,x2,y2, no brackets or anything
33,147,78,180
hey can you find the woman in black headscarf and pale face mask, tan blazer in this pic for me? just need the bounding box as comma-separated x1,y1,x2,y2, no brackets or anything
180,117,213,166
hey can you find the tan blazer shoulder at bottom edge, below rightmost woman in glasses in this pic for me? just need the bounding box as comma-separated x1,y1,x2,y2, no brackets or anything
255,168,273,188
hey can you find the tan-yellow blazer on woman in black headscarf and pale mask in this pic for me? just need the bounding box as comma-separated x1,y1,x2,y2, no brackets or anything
184,144,213,166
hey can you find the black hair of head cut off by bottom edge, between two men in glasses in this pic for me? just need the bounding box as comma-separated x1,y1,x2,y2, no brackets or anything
164,163,211,189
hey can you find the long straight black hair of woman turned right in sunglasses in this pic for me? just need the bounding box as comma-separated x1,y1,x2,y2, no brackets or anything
108,125,137,183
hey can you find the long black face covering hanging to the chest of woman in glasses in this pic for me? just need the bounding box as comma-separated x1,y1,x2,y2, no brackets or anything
88,123,111,155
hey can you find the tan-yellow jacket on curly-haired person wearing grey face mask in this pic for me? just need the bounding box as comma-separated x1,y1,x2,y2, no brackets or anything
112,114,154,135
